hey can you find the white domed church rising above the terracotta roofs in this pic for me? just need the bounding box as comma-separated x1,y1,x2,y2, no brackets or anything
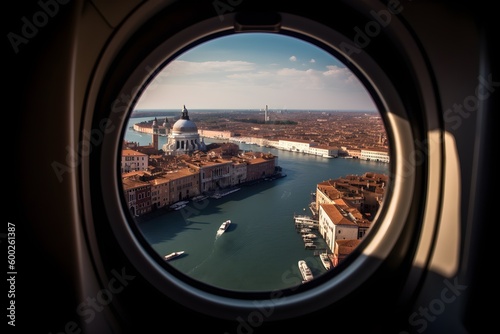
163,106,206,155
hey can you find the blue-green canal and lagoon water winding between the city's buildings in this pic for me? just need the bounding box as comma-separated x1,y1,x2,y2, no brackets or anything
125,118,389,291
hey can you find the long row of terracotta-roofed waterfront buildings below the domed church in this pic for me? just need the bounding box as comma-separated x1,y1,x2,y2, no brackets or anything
122,144,277,216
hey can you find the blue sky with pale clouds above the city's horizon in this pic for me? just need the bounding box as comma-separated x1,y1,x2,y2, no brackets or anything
135,33,377,111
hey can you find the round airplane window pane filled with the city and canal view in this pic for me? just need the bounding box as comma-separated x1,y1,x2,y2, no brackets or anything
118,33,390,292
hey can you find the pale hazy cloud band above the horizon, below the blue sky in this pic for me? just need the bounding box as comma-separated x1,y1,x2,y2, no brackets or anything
138,58,373,110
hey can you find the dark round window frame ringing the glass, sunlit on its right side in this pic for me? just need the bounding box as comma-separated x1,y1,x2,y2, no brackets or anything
82,1,441,319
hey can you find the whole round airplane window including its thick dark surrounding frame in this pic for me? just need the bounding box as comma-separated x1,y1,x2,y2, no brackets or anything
82,2,442,319
